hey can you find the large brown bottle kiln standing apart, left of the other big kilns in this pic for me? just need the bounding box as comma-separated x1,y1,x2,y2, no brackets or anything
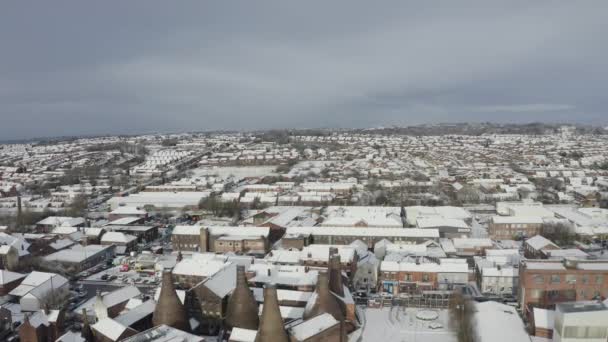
152,270,190,331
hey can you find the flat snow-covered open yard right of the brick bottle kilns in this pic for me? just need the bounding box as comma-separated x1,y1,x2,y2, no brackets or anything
355,307,456,342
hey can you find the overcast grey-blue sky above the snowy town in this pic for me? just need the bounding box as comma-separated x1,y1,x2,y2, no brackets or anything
0,0,608,140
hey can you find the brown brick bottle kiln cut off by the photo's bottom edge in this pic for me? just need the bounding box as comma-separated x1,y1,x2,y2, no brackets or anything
255,284,289,342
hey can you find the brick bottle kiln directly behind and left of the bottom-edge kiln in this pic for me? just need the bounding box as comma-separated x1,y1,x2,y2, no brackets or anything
226,265,259,330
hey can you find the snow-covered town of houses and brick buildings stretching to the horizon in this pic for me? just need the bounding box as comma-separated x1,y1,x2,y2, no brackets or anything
0,125,608,342
